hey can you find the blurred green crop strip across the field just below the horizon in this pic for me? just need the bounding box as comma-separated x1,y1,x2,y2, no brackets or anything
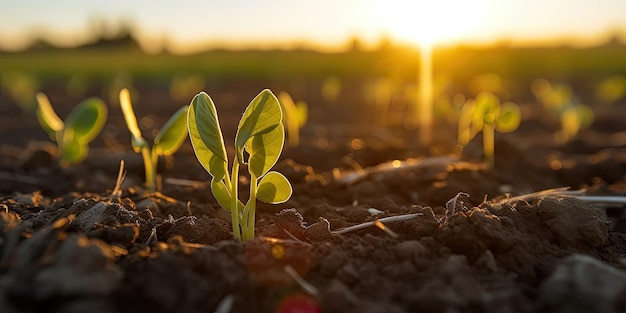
0,45,626,83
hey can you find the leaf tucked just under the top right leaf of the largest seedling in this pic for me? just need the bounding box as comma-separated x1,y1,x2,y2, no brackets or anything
246,123,285,177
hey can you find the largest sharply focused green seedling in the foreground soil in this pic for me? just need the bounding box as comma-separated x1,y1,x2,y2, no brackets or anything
187,89,292,240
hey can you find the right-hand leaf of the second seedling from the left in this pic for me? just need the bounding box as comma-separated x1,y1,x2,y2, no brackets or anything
154,106,188,155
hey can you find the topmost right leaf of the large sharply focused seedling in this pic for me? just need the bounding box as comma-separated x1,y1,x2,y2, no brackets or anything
235,89,283,162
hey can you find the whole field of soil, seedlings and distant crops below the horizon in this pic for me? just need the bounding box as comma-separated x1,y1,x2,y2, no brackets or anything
0,45,626,313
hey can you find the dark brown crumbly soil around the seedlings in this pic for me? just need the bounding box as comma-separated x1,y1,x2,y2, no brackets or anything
0,86,626,313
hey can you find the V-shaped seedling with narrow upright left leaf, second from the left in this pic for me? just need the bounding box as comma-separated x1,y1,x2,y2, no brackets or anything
120,88,188,191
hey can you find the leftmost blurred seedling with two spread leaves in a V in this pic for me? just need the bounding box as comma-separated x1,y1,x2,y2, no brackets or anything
36,92,107,166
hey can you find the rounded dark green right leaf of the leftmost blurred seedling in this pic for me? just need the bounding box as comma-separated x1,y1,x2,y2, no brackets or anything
65,98,107,144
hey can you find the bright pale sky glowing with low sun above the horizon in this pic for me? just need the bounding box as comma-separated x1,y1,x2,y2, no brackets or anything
0,0,626,52
